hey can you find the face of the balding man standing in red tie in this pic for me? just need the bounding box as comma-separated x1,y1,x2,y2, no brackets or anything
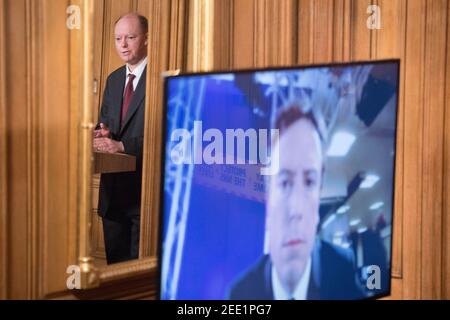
114,15,147,65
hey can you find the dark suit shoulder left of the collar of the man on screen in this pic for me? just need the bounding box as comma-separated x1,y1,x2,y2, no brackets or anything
227,255,273,300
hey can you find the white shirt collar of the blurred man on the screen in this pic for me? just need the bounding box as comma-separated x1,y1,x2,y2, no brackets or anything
272,257,311,300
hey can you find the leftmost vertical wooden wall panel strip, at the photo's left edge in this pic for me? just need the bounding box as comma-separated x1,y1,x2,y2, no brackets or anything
5,0,32,298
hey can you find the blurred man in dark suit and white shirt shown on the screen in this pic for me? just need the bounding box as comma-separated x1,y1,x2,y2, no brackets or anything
229,102,364,300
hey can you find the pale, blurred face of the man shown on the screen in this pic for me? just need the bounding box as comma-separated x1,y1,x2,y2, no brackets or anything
266,118,322,291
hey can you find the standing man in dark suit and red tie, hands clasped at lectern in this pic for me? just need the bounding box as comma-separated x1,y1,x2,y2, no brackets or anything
93,13,148,264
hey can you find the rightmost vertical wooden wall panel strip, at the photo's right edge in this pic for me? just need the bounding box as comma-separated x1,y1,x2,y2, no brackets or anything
421,0,448,299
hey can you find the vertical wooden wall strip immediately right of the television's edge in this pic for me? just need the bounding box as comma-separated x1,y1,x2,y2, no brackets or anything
402,0,426,299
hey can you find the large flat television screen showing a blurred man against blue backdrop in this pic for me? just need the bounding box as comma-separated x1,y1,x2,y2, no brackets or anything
159,60,399,300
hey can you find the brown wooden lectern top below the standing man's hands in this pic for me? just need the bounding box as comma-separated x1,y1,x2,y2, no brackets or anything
94,151,136,173
